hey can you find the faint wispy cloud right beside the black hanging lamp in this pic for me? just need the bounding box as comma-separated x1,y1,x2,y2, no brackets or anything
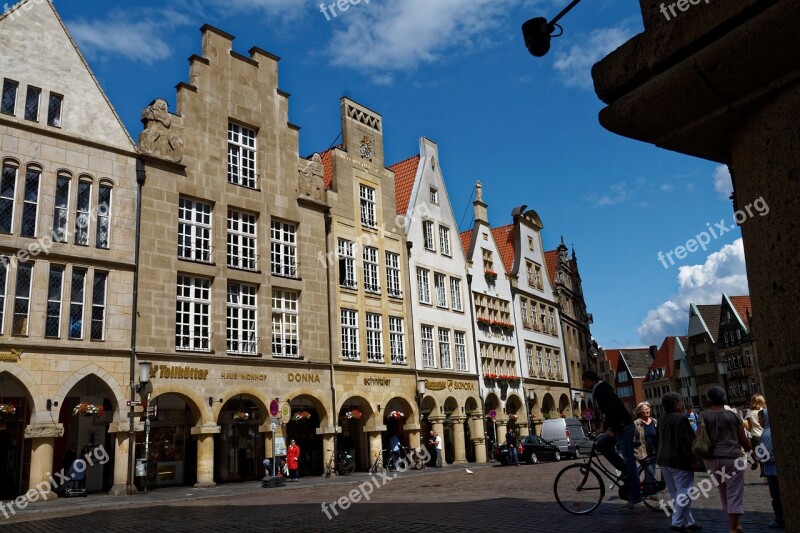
553,22,636,89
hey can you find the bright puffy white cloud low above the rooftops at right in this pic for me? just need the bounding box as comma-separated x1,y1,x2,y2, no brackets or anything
637,238,749,345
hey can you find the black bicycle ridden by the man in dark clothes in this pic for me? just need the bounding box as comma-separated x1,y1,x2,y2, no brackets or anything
553,435,669,514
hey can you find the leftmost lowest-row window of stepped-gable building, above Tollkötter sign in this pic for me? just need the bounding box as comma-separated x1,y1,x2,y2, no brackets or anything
175,274,211,352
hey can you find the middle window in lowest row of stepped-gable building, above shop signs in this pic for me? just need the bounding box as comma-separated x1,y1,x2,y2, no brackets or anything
225,283,258,355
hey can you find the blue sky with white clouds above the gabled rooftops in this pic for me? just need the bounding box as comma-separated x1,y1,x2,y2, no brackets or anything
48,0,758,348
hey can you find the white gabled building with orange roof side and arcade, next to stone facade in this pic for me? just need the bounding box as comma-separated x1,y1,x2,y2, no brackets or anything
389,137,478,463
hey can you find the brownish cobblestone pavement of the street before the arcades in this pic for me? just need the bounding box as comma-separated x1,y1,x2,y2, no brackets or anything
0,461,773,533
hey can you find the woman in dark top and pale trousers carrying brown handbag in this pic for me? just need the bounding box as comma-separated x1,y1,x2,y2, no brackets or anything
697,386,751,533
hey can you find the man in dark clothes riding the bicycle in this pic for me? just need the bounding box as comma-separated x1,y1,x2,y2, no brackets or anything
583,370,642,505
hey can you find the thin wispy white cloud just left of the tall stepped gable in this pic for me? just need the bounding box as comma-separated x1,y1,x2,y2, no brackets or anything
66,9,191,64
